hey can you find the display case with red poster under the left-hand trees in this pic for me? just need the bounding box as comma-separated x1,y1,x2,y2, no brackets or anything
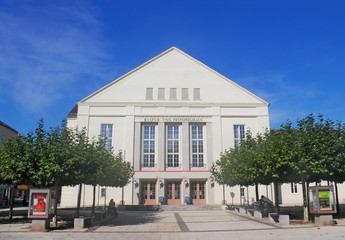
28,189,55,218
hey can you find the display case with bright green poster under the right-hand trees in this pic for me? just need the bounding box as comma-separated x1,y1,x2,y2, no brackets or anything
309,186,337,214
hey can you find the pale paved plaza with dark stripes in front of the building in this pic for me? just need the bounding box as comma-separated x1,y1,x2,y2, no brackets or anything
0,210,345,240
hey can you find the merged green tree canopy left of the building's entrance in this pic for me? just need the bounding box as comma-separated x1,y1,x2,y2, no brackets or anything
0,119,133,187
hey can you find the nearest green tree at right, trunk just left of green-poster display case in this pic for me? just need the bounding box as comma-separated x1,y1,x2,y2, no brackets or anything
286,114,344,221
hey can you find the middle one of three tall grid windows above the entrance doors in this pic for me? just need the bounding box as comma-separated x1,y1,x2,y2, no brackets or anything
167,125,180,167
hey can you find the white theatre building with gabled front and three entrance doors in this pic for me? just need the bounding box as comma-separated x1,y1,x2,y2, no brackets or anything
61,47,276,207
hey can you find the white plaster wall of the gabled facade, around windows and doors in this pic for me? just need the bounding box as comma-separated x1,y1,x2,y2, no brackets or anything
61,48,269,206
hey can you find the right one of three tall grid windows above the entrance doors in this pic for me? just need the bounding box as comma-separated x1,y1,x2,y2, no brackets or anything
191,125,204,167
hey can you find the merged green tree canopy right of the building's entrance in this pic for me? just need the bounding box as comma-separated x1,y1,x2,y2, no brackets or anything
211,114,345,220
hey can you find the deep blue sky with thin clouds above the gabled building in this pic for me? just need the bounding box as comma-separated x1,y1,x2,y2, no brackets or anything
0,0,345,133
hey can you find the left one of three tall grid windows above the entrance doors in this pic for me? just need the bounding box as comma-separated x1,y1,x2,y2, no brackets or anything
142,125,156,167
